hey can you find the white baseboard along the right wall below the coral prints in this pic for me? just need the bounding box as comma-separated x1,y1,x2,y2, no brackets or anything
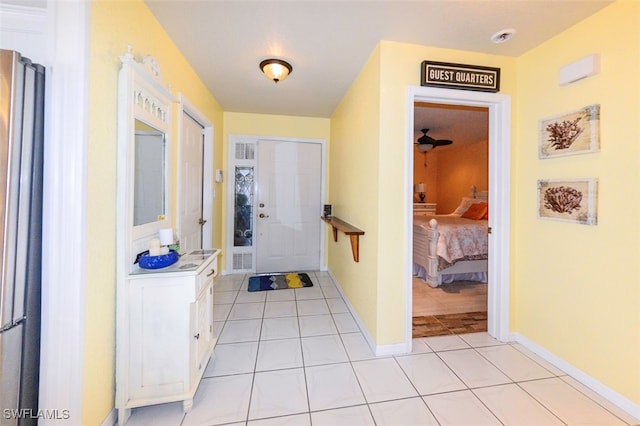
510,333,640,419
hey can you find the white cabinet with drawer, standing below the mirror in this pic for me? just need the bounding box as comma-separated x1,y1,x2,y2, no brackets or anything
116,249,220,424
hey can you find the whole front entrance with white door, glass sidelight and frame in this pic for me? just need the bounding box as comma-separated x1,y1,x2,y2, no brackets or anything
224,135,327,273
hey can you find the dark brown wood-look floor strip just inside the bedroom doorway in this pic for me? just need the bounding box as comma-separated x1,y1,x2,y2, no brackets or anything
412,312,487,339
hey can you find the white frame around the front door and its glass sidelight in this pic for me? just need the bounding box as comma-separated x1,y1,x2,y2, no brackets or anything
223,134,327,274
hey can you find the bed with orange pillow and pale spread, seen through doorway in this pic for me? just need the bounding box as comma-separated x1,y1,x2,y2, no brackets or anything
413,187,489,287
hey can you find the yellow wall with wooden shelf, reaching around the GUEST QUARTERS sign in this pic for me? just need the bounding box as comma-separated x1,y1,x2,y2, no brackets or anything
328,41,515,345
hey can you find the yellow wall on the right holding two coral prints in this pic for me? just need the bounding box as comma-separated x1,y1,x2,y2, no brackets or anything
512,1,640,404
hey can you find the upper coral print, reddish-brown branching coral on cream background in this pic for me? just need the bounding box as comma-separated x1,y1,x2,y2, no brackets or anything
539,105,600,159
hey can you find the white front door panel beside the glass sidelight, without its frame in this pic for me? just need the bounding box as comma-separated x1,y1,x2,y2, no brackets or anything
254,140,322,273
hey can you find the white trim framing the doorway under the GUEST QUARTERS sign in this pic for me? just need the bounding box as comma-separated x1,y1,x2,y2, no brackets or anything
405,86,511,348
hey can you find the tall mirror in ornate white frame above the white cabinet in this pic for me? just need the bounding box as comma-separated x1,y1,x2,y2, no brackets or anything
117,51,176,273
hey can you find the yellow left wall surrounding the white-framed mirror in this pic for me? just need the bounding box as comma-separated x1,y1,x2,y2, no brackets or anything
82,0,222,425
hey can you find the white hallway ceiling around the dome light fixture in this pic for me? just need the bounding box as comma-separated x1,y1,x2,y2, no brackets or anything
145,0,611,121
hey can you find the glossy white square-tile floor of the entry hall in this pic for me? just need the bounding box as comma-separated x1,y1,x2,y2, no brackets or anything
127,272,640,426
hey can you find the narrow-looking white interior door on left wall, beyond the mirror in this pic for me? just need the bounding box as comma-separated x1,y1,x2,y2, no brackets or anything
179,113,205,252
